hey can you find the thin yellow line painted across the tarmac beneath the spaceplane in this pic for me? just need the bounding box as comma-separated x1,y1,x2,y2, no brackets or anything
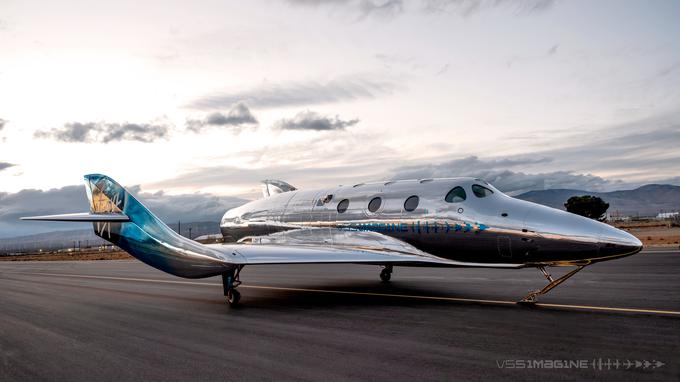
17,272,680,316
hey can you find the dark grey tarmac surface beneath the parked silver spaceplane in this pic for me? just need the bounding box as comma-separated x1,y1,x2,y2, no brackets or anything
0,250,680,381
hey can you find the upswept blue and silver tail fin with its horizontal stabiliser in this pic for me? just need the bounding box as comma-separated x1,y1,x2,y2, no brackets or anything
22,174,233,278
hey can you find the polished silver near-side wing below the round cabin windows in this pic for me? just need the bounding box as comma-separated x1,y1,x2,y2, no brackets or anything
208,228,521,268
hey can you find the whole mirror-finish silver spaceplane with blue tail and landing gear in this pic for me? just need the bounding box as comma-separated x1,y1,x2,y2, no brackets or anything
23,174,642,304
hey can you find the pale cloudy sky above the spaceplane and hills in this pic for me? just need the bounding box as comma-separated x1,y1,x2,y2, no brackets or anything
0,0,680,237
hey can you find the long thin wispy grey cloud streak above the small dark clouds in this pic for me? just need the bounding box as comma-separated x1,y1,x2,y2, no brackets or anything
187,76,395,110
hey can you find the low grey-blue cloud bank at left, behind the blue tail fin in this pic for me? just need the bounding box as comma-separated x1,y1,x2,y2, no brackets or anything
0,185,246,237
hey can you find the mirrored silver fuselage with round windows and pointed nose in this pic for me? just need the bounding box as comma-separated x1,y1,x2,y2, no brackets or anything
220,178,642,265
